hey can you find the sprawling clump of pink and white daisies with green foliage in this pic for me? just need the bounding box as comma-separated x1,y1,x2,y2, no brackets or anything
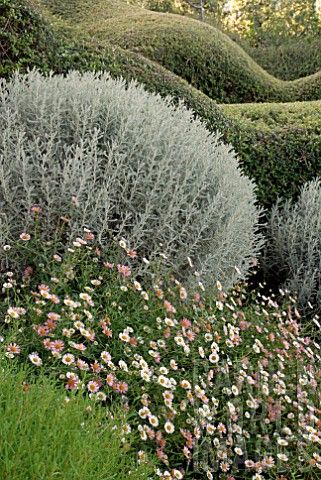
1,231,321,480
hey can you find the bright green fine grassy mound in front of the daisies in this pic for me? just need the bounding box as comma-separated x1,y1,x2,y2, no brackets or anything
0,360,151,480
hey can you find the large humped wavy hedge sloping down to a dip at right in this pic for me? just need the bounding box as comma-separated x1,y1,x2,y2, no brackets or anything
39,0,321,103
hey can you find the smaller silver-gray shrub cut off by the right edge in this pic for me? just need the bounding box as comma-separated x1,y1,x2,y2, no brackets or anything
264,180,321,312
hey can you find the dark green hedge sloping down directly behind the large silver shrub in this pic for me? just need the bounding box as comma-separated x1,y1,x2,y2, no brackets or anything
0,0,226,126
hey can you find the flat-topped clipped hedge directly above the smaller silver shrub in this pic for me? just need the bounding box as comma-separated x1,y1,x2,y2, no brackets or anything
222,101,321,206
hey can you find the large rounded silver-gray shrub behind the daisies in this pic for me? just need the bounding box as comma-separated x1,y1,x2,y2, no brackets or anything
0,71,261,284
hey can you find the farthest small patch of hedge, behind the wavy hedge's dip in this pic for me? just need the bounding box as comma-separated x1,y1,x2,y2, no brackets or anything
241,36,321,80
